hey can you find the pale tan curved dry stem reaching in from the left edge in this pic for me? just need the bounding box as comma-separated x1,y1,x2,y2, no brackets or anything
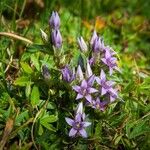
0,32,33,44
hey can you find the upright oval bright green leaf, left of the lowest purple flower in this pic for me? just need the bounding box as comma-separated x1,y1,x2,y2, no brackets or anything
30,85,40,106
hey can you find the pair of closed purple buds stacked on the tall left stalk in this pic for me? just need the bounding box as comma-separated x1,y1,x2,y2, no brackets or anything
49,12,62,48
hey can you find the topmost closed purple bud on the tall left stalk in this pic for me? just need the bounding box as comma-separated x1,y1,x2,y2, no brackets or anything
49,11,60,30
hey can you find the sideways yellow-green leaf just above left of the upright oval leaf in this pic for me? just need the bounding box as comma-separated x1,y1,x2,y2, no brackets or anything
14,76,32,86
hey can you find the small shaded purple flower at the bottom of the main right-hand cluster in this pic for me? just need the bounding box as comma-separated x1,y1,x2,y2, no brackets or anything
92,97,107,111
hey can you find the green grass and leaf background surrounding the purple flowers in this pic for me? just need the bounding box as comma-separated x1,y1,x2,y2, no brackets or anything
0,0,150,150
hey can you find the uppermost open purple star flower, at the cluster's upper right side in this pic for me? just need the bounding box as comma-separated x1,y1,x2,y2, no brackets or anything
101,50,119,75
